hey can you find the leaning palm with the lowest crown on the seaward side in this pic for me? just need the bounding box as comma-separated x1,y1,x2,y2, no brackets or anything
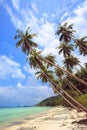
33,59,80,111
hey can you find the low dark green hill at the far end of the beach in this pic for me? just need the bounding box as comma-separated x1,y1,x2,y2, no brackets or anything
36,96,62,106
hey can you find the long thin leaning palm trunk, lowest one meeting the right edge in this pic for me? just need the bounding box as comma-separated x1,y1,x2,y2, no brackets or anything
37,59,87,112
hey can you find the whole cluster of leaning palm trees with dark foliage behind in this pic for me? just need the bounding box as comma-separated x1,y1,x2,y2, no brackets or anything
14,23,87,112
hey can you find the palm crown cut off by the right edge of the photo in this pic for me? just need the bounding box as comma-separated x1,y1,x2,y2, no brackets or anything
74,36,87,56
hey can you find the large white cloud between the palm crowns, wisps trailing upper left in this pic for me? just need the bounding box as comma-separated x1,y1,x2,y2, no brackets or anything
4,3,64,64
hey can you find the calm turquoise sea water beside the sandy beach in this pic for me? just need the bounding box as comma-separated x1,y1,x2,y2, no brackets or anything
0,107,51,128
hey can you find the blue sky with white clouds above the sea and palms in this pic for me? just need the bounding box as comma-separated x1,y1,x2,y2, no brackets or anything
0,0,87,106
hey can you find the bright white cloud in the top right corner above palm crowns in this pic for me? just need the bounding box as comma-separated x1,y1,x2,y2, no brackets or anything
66,0,87,37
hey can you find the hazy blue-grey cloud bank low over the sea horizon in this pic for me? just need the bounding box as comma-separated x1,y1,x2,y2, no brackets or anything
0,82,54,106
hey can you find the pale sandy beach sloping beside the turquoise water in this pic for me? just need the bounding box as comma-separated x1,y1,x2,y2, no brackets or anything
2,106,87,130
